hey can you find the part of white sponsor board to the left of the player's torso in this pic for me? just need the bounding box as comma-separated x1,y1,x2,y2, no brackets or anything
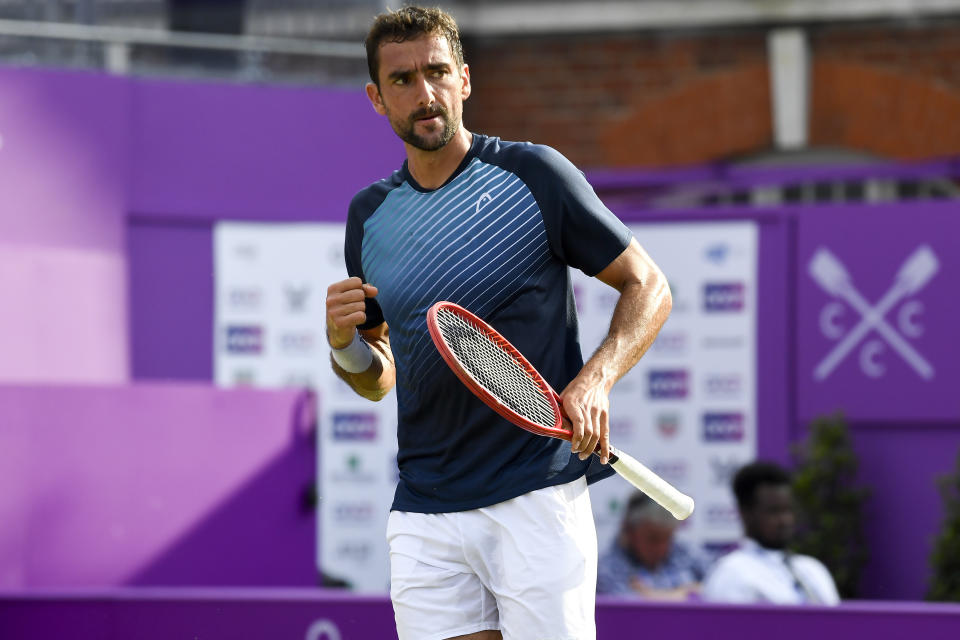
214,223,397,593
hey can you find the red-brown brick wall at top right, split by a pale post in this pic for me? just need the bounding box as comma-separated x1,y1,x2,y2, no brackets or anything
465,20,960,167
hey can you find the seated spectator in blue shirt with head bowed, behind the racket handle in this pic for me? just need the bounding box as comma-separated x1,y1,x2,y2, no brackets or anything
597,491,706,600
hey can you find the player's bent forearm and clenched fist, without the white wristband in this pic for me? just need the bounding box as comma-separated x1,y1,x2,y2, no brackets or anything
327,278,396,401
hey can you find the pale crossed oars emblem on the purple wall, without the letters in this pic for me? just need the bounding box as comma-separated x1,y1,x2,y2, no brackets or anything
808,245,940,380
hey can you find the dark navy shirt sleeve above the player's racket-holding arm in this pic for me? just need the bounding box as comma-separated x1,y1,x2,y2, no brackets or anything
518,145,633,276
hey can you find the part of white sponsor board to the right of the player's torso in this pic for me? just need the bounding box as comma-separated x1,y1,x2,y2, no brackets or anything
574,222,757,553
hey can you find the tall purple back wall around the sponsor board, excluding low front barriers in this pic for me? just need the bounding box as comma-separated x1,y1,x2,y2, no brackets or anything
0,70,960,598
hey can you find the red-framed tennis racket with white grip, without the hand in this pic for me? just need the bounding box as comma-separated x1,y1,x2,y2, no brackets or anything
427,302,693,520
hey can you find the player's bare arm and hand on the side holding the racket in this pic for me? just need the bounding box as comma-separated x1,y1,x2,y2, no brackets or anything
561,240,673,463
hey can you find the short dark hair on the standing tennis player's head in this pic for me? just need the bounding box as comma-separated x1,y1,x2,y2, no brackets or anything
364,7,463,87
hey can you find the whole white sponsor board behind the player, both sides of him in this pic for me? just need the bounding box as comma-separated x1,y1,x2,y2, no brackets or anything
214,222,757,593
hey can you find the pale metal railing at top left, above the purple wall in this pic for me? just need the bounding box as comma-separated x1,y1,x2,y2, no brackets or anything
0,20,366,74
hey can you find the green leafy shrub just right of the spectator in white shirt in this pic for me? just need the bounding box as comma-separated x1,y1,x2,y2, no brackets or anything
793,414,870,599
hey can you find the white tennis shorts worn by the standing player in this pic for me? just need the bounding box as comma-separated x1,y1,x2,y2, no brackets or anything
387,478,597,640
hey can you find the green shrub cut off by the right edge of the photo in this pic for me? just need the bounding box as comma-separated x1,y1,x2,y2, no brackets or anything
926,448,960,602
